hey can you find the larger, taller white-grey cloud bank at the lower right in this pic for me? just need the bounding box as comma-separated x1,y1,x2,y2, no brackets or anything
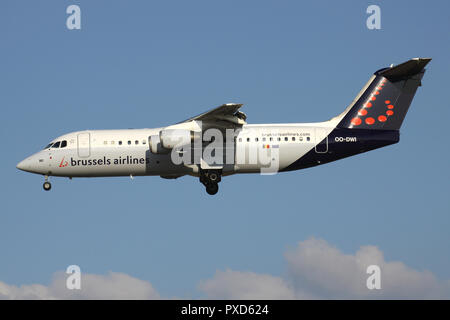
199,238,450,299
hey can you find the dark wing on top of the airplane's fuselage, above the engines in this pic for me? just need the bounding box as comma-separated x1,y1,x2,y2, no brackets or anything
180,103,247,128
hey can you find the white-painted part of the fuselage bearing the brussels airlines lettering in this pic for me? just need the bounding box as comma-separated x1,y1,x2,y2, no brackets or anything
18,120,336,178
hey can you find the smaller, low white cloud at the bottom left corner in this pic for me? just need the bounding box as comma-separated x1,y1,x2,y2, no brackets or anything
0,272,160,300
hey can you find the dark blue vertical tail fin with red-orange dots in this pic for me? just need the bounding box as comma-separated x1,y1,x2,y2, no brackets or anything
338,58,431,130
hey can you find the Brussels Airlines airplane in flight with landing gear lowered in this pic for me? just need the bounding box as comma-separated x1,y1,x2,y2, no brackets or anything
17,58,431,195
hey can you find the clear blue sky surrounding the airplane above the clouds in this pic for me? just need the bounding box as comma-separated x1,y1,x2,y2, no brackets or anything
0,0,450,298
